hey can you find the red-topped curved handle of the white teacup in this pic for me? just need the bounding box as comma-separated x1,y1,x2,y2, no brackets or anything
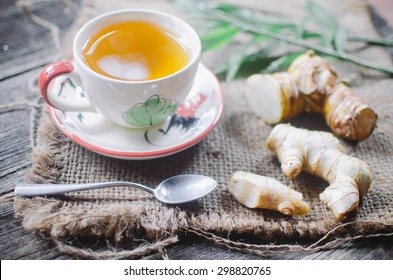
38,61,96,112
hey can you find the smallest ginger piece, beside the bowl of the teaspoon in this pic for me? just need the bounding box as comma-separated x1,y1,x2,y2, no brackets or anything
228,171,310,215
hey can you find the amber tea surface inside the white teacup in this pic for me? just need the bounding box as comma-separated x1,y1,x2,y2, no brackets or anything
82,21,188,81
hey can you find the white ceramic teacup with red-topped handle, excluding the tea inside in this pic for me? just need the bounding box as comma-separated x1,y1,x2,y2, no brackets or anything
39,9,201,128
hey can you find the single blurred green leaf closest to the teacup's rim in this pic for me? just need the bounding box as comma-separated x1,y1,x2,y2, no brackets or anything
201,25,241,51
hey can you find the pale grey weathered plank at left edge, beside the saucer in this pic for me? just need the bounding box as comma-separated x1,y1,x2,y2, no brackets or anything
0,71,38,193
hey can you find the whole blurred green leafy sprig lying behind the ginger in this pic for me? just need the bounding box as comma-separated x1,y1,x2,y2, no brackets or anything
173,0,393,76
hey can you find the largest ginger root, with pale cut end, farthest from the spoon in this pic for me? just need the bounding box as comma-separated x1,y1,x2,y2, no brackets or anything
245,51,377,141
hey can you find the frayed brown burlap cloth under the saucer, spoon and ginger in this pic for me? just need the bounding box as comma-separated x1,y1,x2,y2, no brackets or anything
15,0,393,258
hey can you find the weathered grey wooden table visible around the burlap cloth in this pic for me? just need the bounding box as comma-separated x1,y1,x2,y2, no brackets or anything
0,0,393,259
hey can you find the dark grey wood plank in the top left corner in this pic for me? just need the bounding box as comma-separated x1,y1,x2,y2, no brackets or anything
0,0,80,80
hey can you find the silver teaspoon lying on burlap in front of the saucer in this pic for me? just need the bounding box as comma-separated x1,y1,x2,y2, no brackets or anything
15,174,217,204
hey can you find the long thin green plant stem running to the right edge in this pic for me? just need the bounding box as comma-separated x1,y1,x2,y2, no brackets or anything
204,10,393,74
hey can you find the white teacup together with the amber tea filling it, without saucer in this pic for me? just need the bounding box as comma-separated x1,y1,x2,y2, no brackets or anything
39,9,201,128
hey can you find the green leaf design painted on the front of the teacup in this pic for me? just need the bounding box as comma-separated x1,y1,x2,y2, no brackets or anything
122,95,178,126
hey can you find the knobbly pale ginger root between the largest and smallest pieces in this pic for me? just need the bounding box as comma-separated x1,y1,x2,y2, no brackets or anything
266,124,372,220
